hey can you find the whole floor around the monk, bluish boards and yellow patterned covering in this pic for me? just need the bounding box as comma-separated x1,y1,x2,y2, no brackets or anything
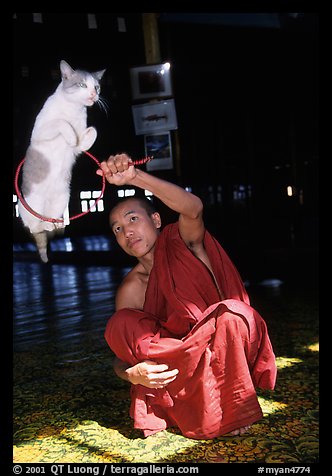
13,247,318,464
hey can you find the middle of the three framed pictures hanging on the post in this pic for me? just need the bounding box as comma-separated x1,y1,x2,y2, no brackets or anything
131,99,178,135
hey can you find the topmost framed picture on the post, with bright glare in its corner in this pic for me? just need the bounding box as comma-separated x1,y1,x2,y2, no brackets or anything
130,63,173,101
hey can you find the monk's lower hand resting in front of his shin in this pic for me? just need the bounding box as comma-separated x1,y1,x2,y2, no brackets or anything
126,360,179,388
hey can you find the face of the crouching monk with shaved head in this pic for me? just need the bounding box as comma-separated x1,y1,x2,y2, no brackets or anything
110,198,161,258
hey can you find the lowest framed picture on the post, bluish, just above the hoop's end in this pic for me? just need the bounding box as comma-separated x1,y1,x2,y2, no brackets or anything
144,131,173,171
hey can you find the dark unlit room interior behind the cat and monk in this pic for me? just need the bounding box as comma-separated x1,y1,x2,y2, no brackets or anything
13,13,319,282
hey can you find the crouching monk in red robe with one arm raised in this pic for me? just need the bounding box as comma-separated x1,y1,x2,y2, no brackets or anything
97,154,276,439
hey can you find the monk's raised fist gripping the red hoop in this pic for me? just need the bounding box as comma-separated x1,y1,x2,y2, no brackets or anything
96,154,137,185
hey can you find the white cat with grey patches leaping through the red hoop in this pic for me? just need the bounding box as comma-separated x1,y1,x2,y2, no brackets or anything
19,60,105,263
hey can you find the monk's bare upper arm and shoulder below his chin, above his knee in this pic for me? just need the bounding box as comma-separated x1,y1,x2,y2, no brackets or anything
115,264,149,310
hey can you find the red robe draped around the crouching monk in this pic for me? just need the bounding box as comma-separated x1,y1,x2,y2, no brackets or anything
105,223,276,439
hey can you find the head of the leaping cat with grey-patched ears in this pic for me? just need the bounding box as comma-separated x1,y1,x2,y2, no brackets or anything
60,60,106,106
